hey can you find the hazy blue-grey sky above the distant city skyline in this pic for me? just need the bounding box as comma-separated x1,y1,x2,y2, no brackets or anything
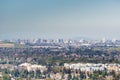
0,0,120,39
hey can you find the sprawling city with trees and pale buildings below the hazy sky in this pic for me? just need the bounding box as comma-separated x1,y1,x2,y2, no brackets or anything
0,38,120,80
